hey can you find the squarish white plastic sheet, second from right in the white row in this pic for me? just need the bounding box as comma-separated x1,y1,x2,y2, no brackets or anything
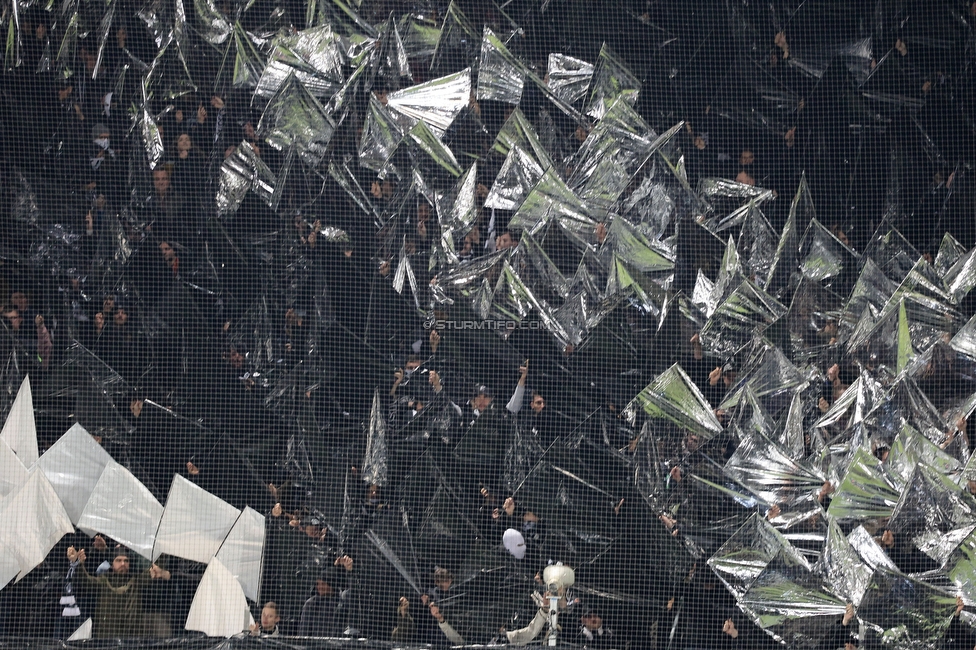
153,475,241,564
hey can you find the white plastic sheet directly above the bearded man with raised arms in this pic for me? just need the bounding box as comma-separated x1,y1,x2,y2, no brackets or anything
78,461,163,560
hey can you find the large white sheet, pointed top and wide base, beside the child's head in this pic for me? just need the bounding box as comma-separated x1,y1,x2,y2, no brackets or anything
184,558,254,638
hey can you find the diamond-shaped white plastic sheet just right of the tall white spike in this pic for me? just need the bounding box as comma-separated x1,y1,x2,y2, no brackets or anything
37,424,112,524
